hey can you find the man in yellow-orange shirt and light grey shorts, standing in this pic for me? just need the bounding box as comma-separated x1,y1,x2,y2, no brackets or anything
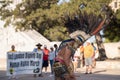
84,41,94,74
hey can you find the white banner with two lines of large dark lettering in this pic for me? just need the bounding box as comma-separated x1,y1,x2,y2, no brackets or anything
7,52,43,76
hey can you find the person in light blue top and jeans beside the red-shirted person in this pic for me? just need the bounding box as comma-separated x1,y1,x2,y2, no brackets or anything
49,47,55,76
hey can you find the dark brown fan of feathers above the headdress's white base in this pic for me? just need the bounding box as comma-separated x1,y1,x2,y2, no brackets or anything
65,12,103,34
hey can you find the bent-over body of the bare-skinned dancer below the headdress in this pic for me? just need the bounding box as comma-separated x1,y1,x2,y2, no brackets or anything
53,39,75,80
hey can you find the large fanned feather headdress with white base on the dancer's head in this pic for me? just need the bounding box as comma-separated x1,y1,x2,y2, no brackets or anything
64,5,112,43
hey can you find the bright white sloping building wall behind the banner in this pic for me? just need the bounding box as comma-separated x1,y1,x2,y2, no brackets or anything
0,26,50,58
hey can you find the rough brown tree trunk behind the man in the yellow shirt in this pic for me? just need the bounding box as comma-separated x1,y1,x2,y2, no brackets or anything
95,33,107,61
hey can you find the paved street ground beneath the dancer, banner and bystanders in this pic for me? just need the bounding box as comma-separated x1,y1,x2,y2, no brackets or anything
0,68,120,80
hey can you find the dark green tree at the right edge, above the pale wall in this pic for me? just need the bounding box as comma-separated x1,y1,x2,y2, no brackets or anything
103,9,120,42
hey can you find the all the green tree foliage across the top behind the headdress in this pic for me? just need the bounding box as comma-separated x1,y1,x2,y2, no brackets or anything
0,0,120,41
